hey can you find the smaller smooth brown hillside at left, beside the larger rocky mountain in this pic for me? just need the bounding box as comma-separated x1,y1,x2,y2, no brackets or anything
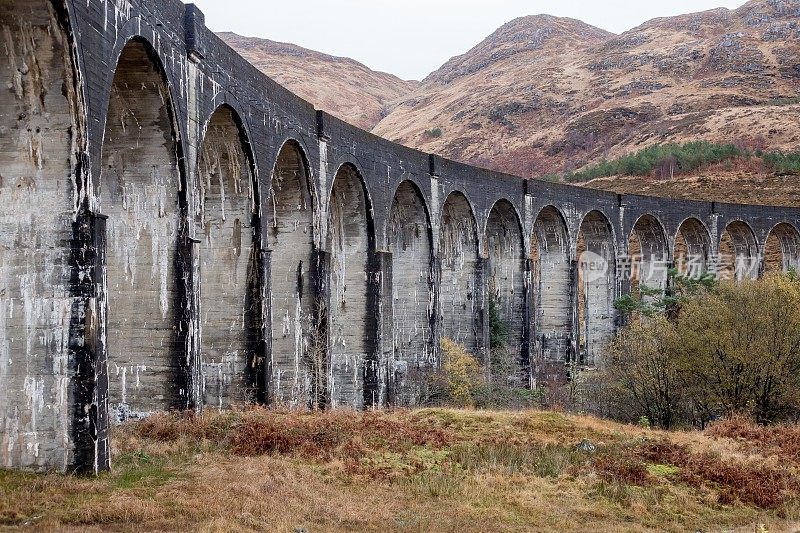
219,33,417,130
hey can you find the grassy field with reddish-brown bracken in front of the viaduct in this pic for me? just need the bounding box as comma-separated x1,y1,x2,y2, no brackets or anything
0,409,800,533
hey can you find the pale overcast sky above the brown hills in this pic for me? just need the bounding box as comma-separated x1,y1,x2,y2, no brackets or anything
194,0,744,79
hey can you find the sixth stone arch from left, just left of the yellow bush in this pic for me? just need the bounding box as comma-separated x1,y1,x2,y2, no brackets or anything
387,180,438,406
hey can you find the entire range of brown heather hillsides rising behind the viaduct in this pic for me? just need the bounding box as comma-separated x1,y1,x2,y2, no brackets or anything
222,0,800,206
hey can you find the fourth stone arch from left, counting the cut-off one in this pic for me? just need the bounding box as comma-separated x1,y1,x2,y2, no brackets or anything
265,140,318,407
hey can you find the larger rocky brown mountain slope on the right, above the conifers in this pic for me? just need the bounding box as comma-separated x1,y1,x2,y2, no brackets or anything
374,0,800,177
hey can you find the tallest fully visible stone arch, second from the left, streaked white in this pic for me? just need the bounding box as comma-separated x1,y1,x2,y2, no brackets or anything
100,39,190,420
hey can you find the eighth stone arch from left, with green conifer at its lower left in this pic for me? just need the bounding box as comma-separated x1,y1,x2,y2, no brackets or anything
486,200,529,386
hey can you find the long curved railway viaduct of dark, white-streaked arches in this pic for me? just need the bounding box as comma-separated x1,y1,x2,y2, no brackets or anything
0,0,800,471
